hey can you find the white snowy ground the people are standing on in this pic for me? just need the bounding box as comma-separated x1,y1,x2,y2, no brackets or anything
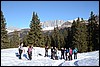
1,47,99,66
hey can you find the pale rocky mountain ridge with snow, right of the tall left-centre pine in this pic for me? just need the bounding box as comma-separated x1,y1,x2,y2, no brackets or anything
41,18,87,31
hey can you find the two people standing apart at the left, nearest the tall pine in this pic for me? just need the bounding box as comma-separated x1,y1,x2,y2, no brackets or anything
18,43,33,60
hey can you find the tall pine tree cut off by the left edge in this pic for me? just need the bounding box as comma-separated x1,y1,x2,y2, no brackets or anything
1,11,9,49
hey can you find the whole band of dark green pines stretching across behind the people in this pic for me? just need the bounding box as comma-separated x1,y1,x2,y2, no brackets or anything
1,11,99,52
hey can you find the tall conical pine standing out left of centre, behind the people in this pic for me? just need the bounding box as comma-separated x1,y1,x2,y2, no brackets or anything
27,12,44,46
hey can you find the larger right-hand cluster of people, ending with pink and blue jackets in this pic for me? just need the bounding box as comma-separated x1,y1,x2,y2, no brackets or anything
45,46,78,60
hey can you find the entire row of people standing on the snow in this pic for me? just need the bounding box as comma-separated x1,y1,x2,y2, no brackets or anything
19,43,78,60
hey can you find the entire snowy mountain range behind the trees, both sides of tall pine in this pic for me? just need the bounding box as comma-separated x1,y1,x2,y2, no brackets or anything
7,18,87,33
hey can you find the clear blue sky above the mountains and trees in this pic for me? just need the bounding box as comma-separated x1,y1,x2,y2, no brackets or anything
1,1,99,28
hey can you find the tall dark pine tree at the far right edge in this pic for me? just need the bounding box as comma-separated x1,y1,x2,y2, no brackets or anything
88,11,99,51
